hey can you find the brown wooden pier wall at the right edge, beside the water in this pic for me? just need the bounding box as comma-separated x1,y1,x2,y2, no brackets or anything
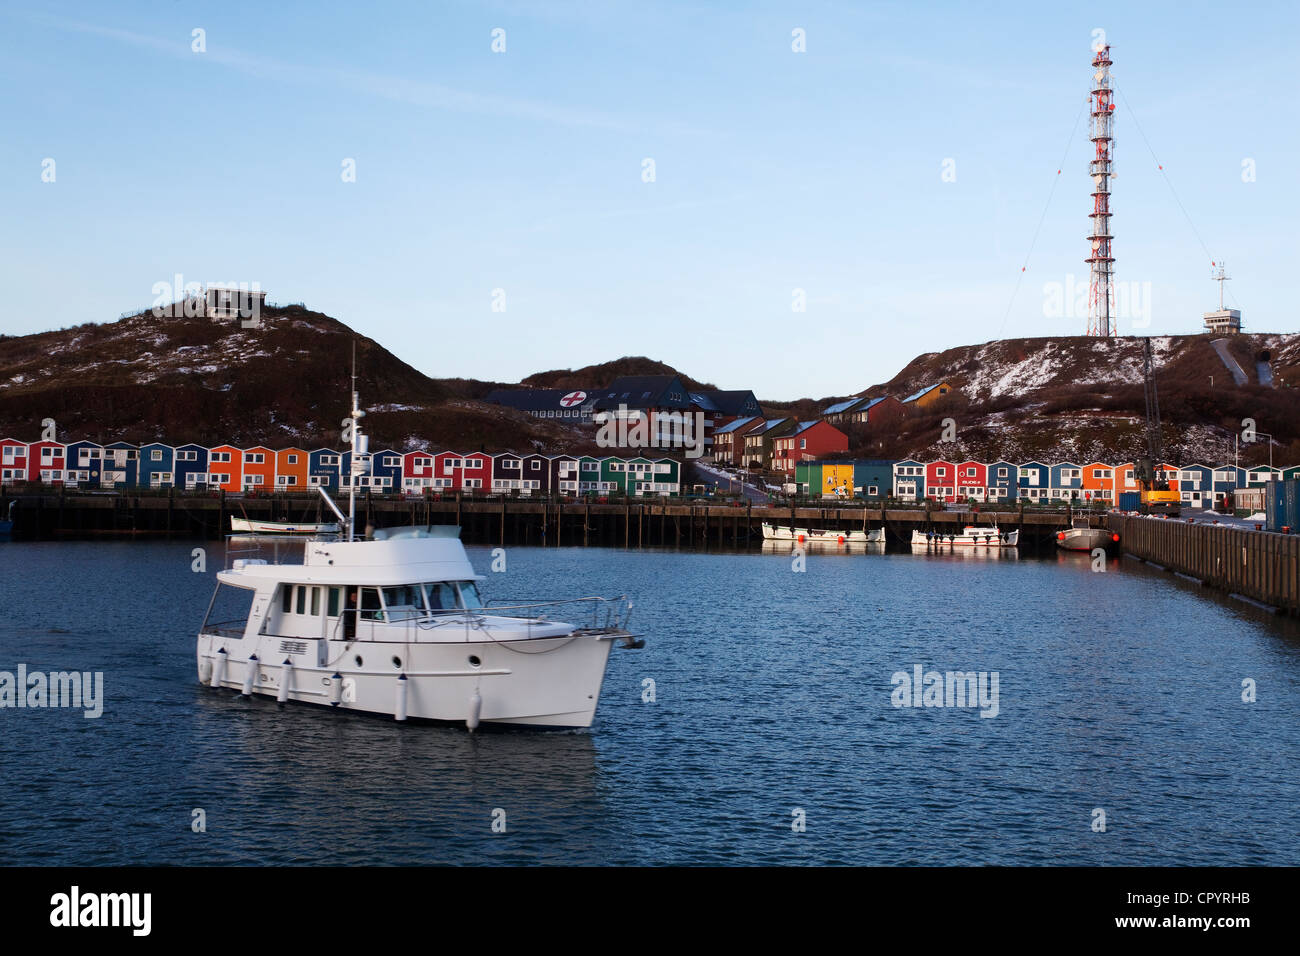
1109,515,1300,614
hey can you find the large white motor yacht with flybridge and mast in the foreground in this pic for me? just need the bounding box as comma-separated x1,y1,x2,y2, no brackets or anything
198,377,644,730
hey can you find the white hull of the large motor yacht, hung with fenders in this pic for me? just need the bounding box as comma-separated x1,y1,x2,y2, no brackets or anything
198,632,616,728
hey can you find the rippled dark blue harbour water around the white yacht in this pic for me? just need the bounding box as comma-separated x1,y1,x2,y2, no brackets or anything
0,541,1300,865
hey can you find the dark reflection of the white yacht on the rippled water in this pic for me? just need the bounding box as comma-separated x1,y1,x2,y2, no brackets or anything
190,688,612,864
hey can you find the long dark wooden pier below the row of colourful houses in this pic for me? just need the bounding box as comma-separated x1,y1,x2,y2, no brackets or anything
0,492,1105,548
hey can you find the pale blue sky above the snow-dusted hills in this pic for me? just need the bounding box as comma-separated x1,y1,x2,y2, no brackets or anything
0,0,1300,399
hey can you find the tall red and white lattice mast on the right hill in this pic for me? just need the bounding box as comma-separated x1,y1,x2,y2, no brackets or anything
1084,46,1115,336
